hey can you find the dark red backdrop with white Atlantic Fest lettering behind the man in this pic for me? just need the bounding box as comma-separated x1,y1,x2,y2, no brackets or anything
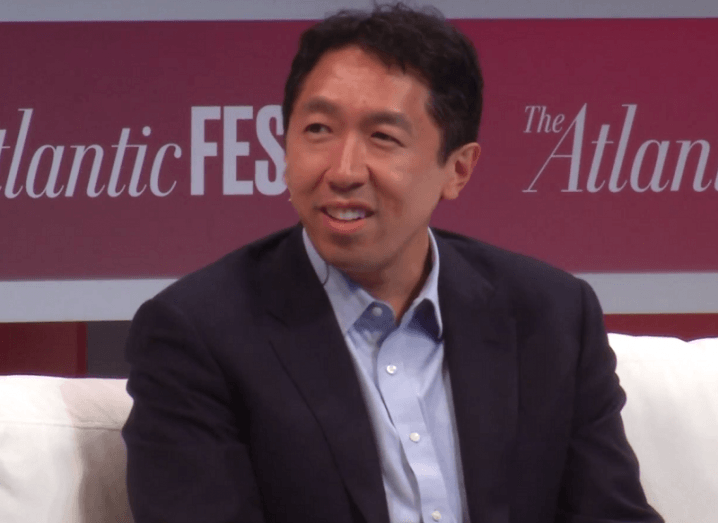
0,14,718,321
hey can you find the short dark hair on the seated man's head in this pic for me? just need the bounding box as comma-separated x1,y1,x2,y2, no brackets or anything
282,2,484,165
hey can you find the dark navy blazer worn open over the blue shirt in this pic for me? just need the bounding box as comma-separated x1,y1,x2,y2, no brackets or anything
123,226,662,523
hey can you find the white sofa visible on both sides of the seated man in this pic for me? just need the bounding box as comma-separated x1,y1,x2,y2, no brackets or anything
0,334,718,523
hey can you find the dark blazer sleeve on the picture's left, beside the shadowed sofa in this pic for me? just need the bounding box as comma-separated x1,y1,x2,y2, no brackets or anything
122,297,264,523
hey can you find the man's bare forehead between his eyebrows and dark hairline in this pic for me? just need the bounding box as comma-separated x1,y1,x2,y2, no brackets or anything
296,46,430,117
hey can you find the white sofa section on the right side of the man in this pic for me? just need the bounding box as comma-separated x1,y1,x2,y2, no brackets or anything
609,334,718,523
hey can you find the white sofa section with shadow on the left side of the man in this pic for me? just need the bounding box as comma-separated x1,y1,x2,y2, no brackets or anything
0,376,132,523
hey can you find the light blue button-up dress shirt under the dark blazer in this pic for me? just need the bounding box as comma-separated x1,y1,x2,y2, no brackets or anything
303,230,469,523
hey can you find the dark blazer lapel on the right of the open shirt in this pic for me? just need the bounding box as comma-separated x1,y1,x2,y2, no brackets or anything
435,234,518,523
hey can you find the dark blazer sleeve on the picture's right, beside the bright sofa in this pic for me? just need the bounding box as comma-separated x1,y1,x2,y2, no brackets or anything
556,281,663,523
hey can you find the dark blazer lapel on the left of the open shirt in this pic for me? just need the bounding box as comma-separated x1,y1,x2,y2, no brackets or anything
262,227,389,523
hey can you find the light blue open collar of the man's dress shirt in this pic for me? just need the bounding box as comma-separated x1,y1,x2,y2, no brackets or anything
302,229,443,338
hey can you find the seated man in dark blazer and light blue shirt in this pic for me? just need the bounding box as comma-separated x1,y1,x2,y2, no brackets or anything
124,6,662,523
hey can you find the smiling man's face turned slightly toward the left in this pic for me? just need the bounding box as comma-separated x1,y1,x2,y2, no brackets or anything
285,46,478,275
